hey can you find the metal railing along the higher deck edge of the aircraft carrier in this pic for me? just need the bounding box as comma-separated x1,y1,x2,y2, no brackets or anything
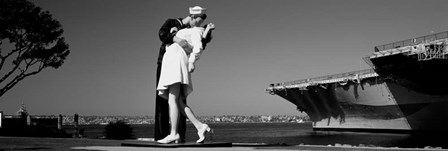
375,31,448,52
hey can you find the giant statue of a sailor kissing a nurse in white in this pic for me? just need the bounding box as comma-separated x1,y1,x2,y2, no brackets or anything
154,6,215,144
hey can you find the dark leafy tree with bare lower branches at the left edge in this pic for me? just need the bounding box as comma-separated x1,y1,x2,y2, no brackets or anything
0,0,70,97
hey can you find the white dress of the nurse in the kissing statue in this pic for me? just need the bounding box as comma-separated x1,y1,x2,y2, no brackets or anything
157,27,204,99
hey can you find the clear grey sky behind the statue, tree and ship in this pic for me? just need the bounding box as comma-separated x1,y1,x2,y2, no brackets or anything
0,0,448,116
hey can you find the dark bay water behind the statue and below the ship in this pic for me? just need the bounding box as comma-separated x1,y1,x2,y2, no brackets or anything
65,123,448,148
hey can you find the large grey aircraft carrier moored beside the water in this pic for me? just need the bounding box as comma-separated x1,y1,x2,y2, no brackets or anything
266,32,448,132
